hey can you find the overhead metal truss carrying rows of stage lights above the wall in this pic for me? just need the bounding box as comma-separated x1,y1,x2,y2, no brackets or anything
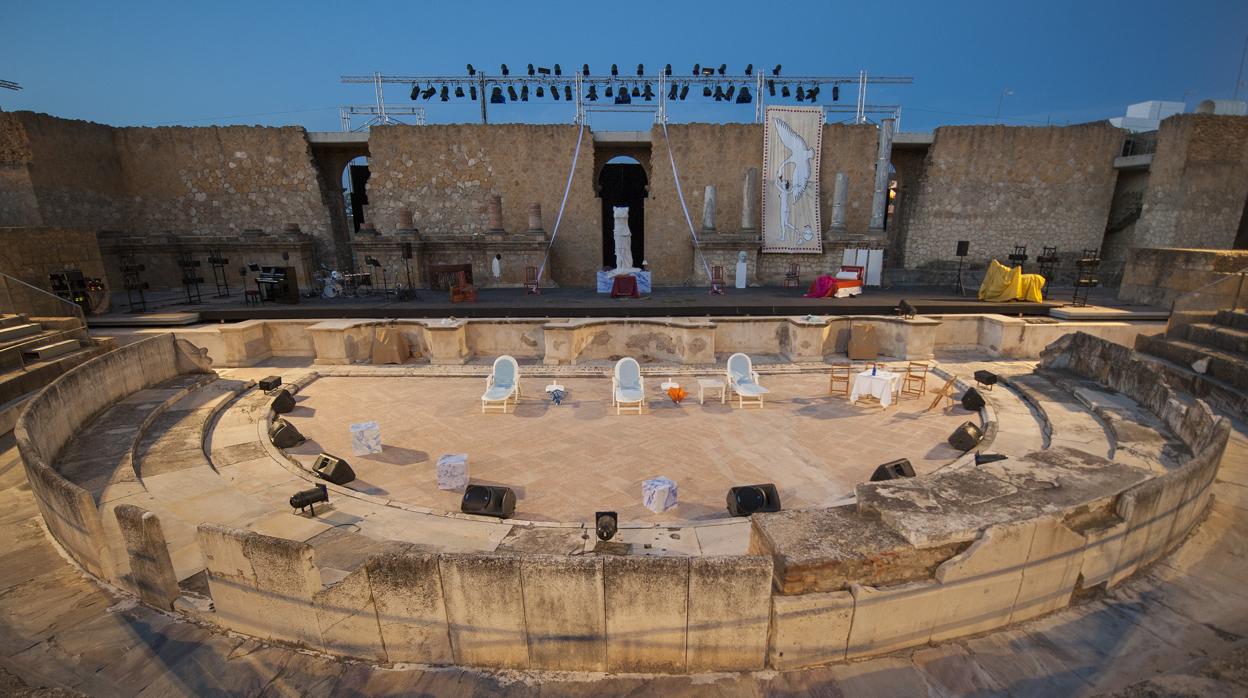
342,66,915,124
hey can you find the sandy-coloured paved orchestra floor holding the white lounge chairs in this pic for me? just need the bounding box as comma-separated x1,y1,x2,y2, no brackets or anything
287,375,971,522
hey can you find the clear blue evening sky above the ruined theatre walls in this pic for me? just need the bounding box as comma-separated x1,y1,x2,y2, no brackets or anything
0,0,1248,131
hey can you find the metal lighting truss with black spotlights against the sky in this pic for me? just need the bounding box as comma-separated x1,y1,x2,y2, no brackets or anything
342,64,915,124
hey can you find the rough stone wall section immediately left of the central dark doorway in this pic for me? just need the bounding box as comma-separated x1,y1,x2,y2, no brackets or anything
368,124,596,286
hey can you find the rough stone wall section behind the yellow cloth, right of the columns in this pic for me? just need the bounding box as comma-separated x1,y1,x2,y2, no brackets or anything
902,122,1123,268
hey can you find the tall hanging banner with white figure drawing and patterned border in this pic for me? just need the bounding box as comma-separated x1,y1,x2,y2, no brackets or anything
763,106,824,253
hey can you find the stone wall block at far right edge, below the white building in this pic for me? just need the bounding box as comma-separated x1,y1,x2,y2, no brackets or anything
1136,114,1248,248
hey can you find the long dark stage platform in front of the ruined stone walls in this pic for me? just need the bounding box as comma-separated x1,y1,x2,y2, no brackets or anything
89,286,1152,326
